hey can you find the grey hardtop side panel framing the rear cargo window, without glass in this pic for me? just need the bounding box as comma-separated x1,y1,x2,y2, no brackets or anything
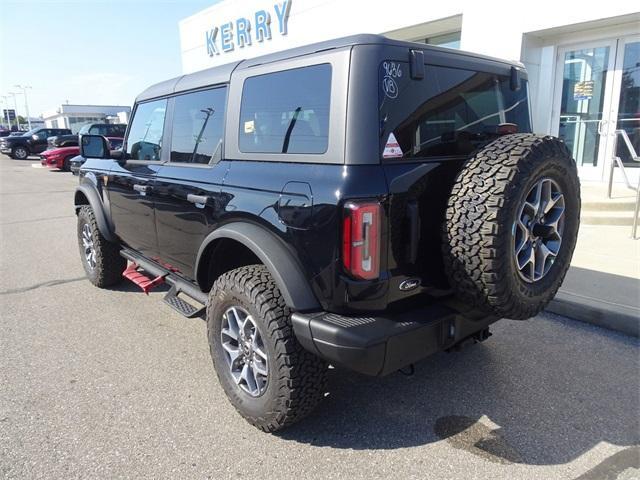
223,47,351,165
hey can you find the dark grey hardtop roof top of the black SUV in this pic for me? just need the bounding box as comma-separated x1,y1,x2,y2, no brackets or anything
136,34,522,103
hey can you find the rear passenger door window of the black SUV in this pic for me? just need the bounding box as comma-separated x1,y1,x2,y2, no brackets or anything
171,87,227,164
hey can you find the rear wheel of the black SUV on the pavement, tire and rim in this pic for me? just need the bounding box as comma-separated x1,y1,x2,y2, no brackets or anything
207,265,327,432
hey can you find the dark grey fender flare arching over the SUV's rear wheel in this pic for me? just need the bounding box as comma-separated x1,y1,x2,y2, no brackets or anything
194,222,320,311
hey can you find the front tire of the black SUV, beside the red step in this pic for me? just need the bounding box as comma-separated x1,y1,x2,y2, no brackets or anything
78,205,127,288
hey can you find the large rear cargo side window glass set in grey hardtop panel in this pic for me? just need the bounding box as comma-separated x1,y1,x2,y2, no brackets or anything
239,64,331,154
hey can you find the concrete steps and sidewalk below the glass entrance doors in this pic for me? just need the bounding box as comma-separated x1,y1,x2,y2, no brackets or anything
547,184,640,336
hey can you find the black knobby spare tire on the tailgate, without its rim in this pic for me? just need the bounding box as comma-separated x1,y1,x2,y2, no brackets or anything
442,134,580,320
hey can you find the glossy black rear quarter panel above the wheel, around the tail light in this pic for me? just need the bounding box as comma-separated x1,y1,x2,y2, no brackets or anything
220,161,387,311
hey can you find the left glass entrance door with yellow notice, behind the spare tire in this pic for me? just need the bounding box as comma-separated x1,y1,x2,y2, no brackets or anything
554,40,616,180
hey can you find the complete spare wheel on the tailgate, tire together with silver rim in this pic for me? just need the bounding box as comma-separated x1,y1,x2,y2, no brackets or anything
442,134,580,320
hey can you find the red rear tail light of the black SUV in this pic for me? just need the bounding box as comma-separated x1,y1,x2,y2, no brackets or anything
342,202,380,280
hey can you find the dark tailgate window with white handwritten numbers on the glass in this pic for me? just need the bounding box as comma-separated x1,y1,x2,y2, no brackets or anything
379,62,531,159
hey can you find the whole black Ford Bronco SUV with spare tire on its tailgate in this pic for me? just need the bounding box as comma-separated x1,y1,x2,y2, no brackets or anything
75,35,580,431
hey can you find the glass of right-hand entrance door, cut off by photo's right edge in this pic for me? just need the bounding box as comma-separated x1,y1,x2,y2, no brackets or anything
617,42,640,167
